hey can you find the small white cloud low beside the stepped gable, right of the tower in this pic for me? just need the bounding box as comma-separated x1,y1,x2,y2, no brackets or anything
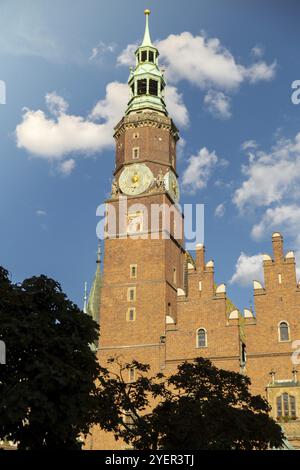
229,252,263,287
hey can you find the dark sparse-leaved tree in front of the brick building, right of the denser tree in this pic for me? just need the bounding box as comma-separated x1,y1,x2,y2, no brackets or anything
98,357,283,450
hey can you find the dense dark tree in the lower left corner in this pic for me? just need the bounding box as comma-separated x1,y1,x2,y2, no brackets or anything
0,268,99,449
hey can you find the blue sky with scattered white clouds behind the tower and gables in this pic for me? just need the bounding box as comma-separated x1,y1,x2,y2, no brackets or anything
0,0,300,308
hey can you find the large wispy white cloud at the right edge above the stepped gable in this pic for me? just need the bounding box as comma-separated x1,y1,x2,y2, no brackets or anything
233,133,300,277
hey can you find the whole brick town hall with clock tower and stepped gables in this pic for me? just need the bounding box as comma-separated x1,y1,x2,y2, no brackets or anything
86,10,300,449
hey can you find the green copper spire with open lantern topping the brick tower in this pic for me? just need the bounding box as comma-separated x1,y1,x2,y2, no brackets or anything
126,10,168,115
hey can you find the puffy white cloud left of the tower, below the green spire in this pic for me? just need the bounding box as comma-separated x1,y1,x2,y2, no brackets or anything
16,82,128,161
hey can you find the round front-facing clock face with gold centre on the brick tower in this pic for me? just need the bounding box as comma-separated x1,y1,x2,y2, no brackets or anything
119,163,154,196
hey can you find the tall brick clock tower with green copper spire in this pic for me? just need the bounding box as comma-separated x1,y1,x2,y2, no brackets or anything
98,10,185,379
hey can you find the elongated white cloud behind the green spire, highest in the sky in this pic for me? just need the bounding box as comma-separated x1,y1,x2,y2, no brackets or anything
117,32,276,90
